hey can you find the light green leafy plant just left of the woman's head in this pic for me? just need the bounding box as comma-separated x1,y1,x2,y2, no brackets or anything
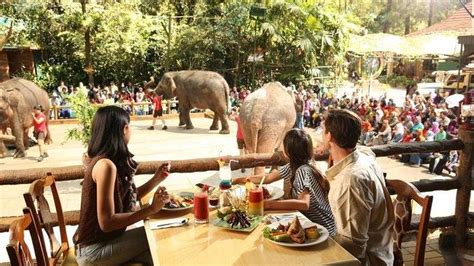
66,90,98,146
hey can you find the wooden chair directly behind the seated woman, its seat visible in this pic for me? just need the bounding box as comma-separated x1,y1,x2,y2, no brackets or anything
23,173,77,265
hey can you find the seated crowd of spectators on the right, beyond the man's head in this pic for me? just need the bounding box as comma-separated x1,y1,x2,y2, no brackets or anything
288,80,459,177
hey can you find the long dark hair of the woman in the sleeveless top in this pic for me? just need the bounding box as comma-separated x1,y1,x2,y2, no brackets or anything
87,105,137,177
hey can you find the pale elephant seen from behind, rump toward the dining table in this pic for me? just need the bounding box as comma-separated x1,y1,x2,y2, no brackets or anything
239,82,296,175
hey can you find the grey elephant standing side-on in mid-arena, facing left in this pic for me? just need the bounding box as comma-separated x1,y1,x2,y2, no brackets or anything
156,70,230,134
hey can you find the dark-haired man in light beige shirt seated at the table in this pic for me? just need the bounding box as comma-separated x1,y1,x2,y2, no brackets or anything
321,110,394,265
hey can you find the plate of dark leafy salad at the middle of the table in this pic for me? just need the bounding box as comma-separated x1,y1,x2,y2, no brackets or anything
213,207,262,233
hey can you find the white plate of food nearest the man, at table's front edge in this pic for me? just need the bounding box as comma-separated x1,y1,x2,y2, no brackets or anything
263,216,329,247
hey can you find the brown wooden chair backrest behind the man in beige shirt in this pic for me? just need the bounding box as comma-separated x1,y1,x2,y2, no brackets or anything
386,179,433,265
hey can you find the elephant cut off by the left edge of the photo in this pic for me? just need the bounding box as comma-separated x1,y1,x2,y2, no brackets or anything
0,78,51,158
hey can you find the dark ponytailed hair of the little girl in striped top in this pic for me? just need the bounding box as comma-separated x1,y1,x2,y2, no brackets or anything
283,128,329,196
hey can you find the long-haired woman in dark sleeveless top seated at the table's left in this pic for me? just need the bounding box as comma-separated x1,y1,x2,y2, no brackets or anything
75,106,173,265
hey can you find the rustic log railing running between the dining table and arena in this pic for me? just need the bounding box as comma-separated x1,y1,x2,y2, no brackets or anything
0,129,474,246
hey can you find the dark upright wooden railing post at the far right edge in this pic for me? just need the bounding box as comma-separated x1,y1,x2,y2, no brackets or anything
455,128,474,247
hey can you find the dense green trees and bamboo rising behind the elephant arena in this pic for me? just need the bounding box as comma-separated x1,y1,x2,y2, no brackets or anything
0,0,457,89
